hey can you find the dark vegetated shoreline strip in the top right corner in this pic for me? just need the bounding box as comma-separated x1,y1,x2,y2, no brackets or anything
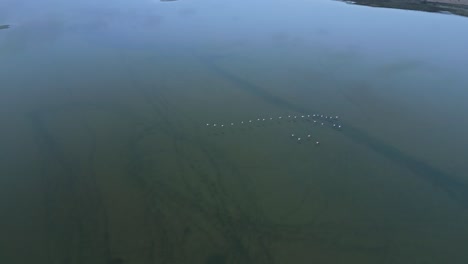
338,0,468,17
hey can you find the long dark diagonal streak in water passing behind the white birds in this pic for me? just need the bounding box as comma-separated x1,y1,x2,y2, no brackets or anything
199,56,468,208
